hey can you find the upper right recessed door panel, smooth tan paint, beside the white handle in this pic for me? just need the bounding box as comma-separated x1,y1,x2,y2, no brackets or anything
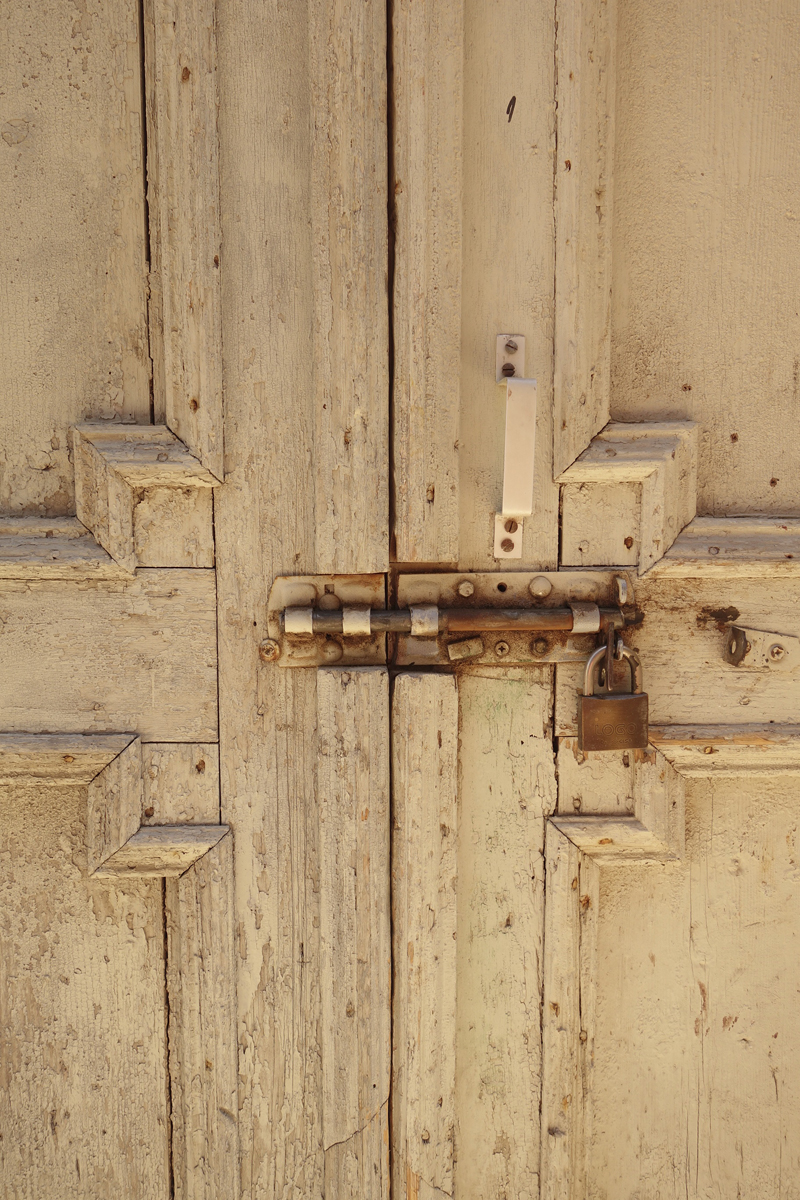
612,0,800,516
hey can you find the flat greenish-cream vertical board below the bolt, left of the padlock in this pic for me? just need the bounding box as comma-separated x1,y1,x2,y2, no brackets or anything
455,667,555,1196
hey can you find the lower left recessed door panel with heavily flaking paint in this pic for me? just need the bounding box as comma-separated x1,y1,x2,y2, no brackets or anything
0,786,170,1200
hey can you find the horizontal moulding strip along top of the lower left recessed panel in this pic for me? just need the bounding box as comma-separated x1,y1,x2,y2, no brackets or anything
0,733,133,788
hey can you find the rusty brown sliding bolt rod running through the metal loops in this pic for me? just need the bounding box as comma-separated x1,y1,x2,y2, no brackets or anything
284,608,625,634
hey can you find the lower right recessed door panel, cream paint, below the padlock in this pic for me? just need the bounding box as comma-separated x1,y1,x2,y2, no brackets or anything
588,776,800,1200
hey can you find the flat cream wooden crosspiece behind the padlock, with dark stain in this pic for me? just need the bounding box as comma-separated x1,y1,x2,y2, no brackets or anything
555,575,800,737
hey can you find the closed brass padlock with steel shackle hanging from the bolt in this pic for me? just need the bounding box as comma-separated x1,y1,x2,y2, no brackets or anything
578,642,649,750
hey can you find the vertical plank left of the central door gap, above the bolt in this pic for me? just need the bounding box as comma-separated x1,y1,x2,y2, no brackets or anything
311,0,389,572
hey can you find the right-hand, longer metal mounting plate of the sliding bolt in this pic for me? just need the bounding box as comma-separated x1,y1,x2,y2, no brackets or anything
392,570,633,666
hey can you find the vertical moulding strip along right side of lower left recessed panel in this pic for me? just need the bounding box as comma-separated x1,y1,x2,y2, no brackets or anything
164,833,240,1200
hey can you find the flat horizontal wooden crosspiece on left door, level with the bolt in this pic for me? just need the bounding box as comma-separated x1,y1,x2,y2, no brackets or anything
0,570,217,742
